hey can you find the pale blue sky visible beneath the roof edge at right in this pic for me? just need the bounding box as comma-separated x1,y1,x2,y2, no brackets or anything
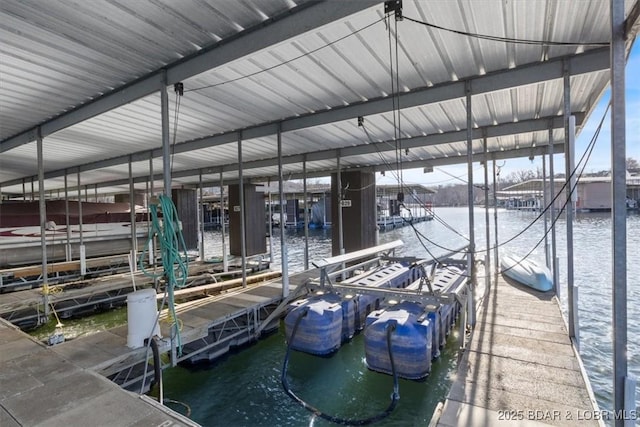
376,42,640,186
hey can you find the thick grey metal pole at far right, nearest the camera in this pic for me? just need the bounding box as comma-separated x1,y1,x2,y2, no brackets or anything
610,0,635,426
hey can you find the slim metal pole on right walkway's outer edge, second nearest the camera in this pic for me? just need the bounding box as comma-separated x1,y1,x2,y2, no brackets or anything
564,66,580,349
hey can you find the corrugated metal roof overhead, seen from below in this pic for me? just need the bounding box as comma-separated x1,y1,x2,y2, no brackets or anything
0,0,637,197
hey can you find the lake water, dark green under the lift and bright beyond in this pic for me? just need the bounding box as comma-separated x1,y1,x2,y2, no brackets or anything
165,208,640,426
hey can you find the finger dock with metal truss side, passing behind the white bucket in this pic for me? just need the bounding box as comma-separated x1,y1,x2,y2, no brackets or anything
35,270,317,392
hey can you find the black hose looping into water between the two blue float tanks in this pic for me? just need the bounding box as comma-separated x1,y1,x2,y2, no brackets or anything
281,307,400,426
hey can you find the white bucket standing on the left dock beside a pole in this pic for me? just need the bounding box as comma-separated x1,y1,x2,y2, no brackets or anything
127,289,160,348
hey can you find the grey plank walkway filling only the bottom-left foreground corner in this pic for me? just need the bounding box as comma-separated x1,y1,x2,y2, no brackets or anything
0,319,197,427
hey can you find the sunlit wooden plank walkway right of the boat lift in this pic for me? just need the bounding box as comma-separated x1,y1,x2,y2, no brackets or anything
437,277,599,427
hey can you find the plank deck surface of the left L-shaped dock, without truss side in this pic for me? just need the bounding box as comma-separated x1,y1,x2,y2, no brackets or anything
0,270,318,427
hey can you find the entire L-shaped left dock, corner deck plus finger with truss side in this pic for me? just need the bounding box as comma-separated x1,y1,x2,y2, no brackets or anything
0,270,318,427
